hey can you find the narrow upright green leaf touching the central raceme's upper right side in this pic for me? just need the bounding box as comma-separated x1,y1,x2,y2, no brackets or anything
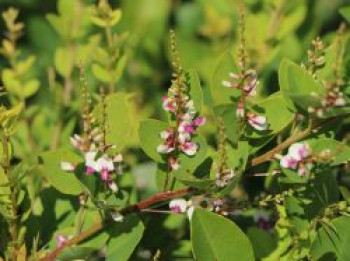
186,70,203,114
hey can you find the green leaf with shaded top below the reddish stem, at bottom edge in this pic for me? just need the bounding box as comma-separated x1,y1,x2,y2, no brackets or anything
106,216,144,261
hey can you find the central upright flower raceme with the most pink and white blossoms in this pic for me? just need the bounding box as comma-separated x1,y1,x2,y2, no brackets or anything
157,78,205,170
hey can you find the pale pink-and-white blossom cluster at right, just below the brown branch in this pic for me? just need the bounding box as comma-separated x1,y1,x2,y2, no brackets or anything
280,143,312,176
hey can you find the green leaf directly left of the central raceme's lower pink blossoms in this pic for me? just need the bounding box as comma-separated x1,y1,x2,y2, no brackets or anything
139,119,168,163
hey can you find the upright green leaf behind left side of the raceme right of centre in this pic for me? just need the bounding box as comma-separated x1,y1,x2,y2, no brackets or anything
210,49,240,105
